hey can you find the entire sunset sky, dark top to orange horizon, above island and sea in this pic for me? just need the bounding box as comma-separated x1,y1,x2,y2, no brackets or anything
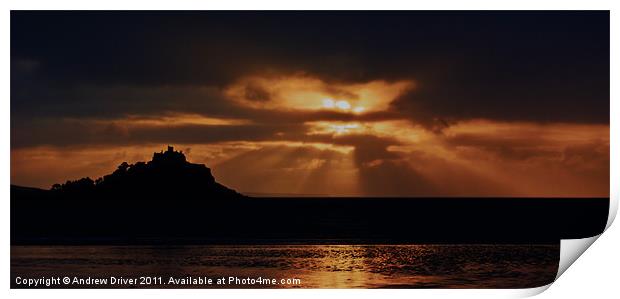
11,12,609,197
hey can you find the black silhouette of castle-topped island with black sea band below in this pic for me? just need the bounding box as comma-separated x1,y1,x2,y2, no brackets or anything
11,147,609,245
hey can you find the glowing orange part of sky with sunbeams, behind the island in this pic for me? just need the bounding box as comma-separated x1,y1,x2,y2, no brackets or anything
11,74,609,197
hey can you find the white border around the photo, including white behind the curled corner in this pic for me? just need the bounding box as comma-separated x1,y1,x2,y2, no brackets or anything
0,0,620,298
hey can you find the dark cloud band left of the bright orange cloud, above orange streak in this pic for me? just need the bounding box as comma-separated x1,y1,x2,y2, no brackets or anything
11,85,238,120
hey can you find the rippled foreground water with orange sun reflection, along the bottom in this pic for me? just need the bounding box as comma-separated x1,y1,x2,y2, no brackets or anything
11,245,560,288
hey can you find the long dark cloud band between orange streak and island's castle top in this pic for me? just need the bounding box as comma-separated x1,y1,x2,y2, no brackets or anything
11,113,400,150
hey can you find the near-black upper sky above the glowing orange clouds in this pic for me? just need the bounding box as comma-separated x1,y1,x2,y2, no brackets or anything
11,11,609,123
